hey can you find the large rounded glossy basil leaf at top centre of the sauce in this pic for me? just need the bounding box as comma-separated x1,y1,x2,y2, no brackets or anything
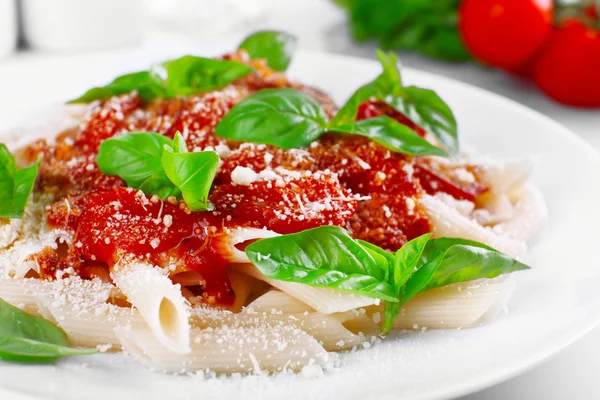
215,88,327,149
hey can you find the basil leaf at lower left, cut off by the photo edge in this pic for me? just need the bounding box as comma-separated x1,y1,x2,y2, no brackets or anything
0,299,96,363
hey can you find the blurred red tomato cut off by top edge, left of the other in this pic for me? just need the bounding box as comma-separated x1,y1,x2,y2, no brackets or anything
459,0,553,71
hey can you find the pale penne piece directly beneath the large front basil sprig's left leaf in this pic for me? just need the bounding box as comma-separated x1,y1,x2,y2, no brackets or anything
232,264,379,314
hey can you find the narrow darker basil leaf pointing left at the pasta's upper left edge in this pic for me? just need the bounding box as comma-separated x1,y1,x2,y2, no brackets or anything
69,71,162,104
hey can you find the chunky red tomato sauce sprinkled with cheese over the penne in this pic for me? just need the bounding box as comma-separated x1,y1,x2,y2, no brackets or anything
27,74,485,305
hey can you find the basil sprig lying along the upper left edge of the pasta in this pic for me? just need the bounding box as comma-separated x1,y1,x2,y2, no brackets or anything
69,56,253,104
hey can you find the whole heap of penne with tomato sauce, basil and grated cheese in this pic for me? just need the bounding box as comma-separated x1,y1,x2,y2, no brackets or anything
0,31,546,373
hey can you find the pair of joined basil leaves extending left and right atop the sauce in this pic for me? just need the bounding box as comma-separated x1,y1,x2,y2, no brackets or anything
215,88,447,156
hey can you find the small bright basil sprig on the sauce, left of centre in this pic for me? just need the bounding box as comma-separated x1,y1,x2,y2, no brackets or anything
96,132,219,211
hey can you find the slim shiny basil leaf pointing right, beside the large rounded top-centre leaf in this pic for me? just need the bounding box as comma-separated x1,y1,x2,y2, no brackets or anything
332,115,448,157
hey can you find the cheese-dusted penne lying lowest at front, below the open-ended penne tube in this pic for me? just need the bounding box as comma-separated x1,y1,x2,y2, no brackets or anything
116,326,332,374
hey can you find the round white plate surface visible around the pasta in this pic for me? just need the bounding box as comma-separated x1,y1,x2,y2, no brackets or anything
0,52,600,400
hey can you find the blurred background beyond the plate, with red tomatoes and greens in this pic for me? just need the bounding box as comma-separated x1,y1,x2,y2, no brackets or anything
0,0,600,400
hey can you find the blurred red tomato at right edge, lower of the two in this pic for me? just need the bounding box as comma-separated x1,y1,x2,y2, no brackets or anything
532,20,600,107
